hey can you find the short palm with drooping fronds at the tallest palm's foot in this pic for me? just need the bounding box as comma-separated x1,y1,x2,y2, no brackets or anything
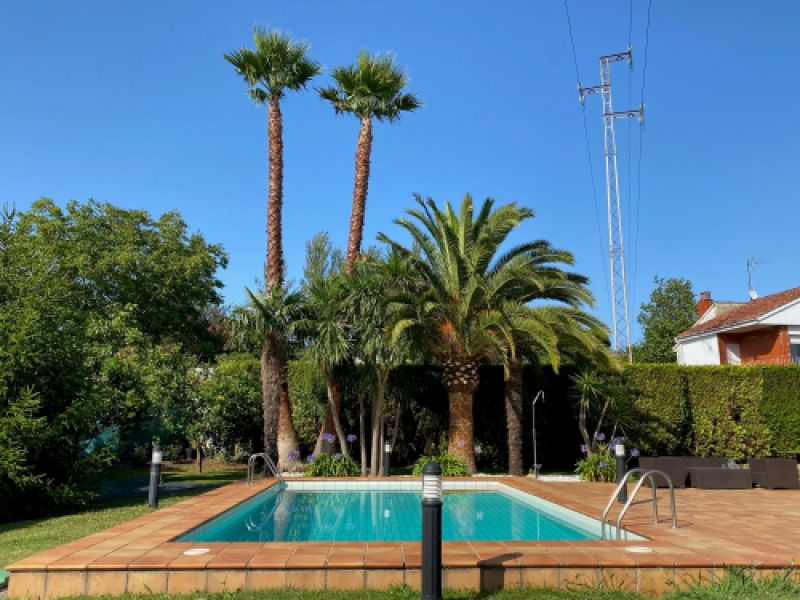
231,288,302,471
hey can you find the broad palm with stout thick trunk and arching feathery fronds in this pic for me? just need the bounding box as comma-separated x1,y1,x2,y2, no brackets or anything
379,195,552,472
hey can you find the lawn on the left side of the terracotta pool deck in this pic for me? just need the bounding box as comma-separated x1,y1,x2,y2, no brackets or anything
0,470,243,568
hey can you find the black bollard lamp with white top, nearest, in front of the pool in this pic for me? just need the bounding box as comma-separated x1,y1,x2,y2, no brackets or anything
422,461,442,600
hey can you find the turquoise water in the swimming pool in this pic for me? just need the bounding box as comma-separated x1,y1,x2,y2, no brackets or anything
176,486,597,542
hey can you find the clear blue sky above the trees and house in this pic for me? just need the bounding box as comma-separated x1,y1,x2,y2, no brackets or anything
0,0,800,340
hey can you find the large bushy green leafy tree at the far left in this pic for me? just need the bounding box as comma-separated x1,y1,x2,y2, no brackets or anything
0,199,226,518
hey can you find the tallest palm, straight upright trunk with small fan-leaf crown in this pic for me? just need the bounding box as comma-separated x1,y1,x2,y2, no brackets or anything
224,28,321,460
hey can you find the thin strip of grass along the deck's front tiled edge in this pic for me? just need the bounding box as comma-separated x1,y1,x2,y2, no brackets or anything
23,569,800,600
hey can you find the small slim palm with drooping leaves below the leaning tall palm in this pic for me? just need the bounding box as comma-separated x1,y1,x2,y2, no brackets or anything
298,276,350,457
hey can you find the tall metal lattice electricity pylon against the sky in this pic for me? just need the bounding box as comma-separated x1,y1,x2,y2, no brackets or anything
578,48,644,362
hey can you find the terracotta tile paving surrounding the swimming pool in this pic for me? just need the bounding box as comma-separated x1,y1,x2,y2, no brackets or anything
7,477,800,599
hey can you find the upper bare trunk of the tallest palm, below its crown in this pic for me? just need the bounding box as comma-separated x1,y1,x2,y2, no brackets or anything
264,98,283,290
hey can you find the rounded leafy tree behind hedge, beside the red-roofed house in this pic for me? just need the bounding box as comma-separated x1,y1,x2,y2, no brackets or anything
635,277,697,363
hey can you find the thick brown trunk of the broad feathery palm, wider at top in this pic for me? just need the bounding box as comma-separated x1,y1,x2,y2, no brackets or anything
442,357,480,474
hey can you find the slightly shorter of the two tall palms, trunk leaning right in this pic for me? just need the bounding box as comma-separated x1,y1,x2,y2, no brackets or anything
319,51,421,272
